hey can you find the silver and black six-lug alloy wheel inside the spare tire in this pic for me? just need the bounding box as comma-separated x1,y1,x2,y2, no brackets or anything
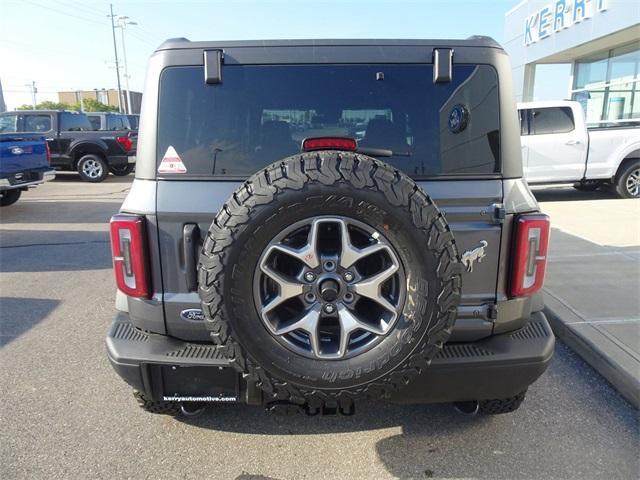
254,216,406,359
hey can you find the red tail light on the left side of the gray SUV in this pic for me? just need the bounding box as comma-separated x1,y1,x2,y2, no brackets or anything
111,214,150,297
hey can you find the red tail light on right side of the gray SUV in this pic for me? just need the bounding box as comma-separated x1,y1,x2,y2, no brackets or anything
511,214,549,297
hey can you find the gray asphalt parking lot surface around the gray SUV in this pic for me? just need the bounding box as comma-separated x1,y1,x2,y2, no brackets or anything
0,175,640,480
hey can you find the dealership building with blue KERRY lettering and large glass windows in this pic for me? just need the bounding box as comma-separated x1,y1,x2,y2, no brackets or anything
504,0,640,126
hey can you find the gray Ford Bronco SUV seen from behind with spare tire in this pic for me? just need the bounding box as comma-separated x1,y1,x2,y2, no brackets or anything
107,37,554,415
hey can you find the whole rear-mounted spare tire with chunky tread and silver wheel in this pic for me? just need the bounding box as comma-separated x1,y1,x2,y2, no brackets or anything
198,151,462,406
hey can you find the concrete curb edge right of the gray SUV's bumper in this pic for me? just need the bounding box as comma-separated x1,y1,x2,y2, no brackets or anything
545,295,640,410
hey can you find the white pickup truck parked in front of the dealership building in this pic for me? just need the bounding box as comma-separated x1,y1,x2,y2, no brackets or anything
518,101,640,198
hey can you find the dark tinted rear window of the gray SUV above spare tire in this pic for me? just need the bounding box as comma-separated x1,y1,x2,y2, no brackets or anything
157,64,499,178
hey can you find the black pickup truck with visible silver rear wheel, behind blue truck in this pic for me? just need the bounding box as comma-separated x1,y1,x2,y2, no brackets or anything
0,110,136,182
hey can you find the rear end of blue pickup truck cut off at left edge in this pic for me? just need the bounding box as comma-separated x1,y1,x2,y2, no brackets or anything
0,133,56,207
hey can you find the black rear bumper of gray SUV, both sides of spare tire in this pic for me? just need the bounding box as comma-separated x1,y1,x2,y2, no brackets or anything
106,312,555,404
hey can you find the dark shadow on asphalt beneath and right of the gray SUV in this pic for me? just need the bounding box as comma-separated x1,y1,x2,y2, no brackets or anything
176,343,638,479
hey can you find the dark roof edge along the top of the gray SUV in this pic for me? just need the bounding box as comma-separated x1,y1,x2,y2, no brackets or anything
156,35,502,51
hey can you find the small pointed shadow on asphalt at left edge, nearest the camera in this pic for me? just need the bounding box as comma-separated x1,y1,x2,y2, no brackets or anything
0,297,60,347
